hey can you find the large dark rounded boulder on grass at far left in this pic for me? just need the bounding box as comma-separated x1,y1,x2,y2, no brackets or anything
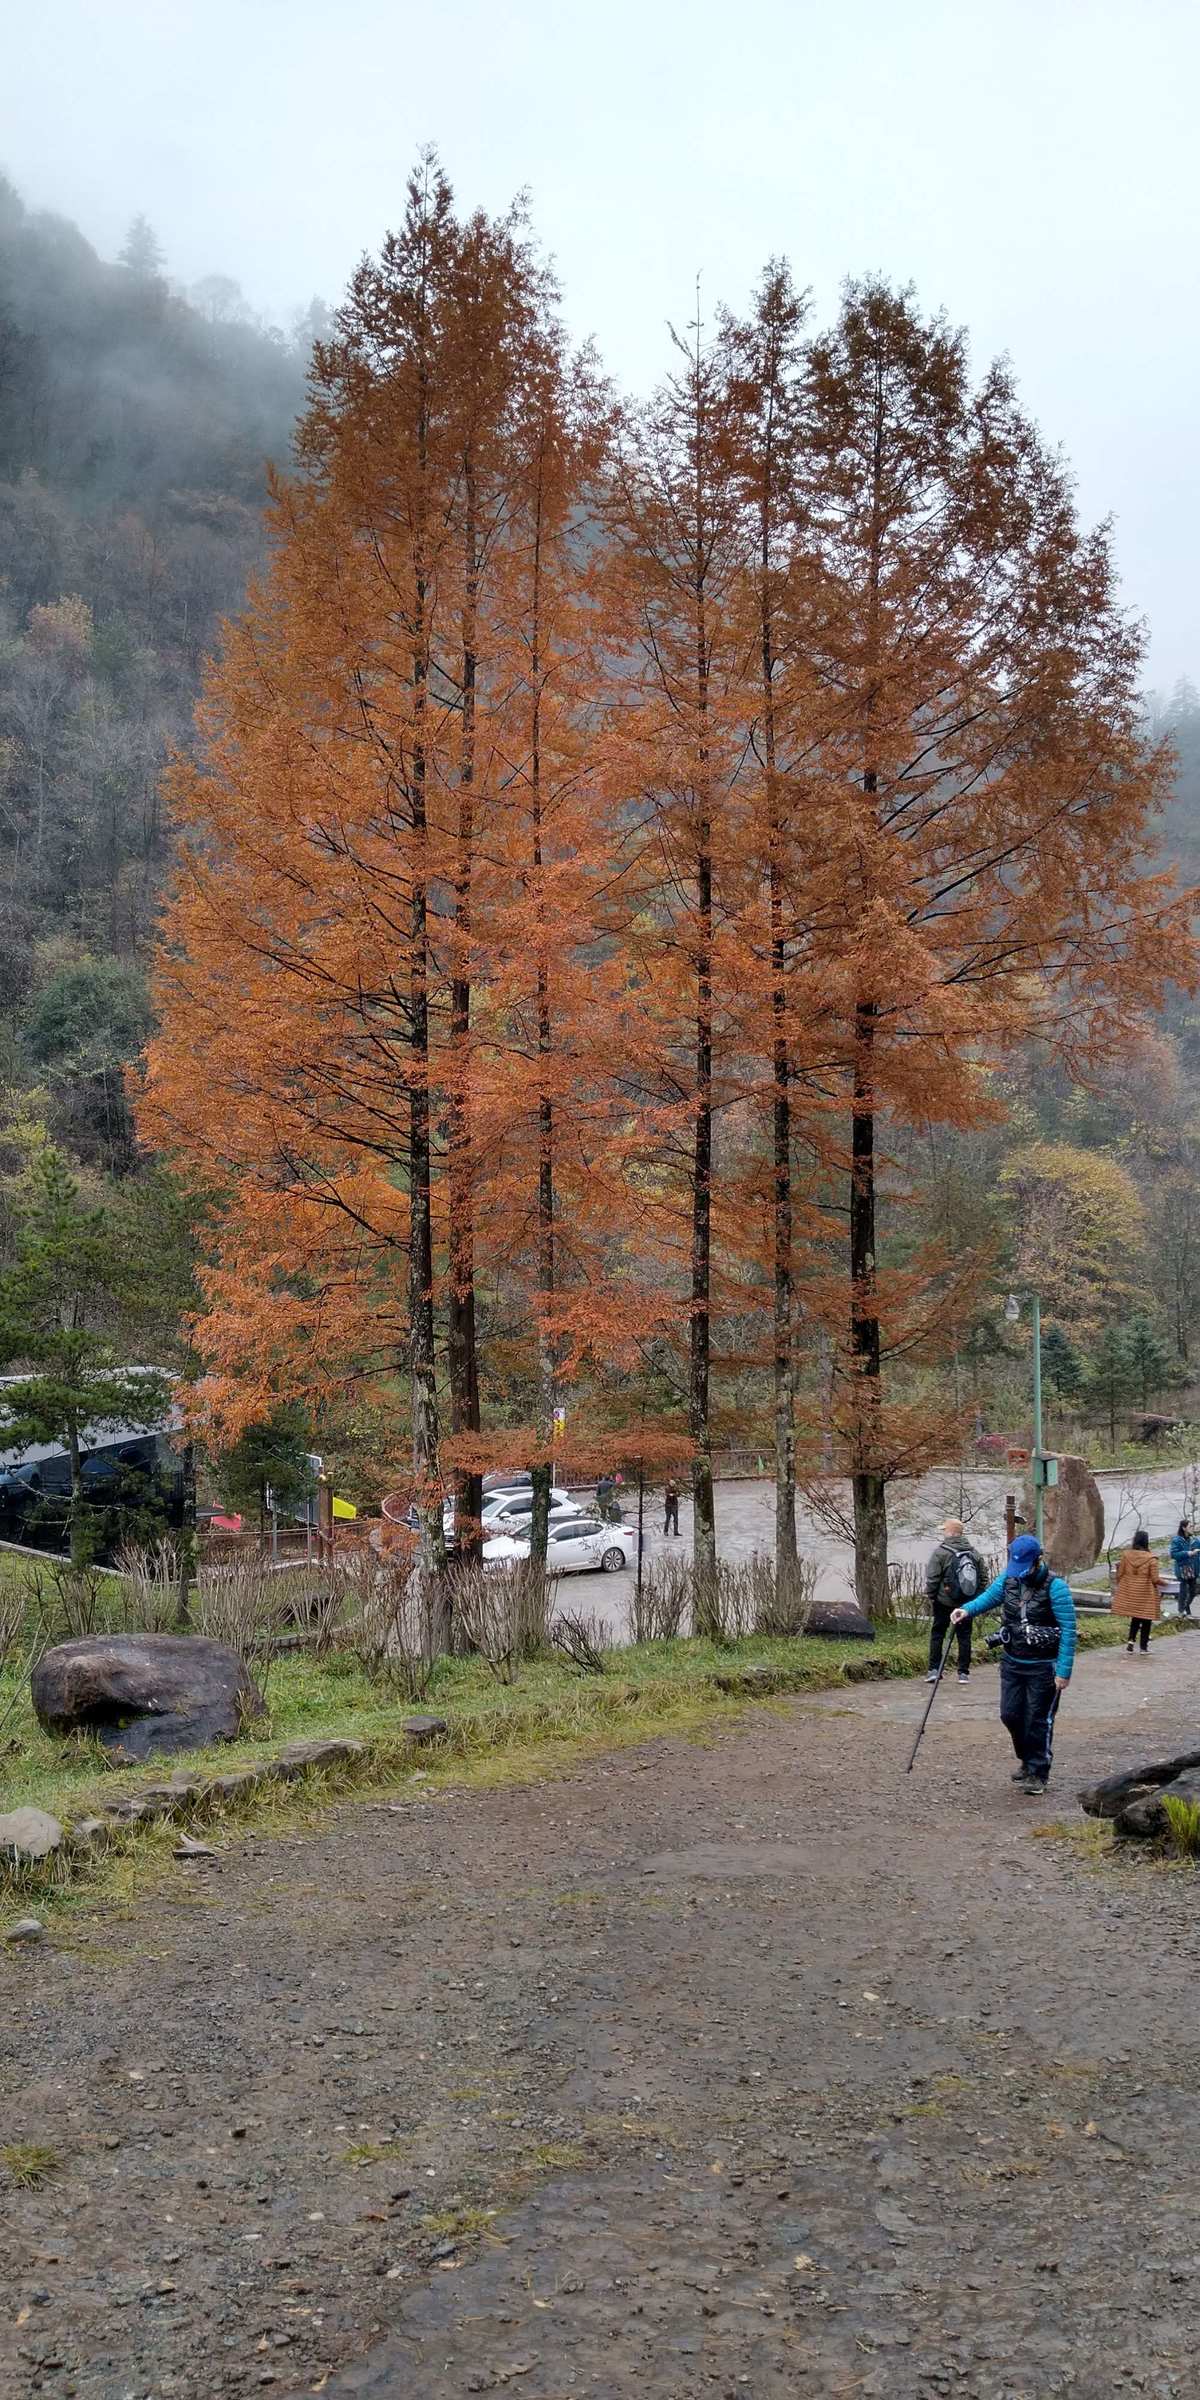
31,1634,262,1759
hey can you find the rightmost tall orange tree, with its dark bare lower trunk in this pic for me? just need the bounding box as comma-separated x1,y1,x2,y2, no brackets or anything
797,283,1185,1608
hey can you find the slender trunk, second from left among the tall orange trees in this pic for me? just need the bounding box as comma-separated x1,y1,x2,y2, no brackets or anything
446,458,482,1565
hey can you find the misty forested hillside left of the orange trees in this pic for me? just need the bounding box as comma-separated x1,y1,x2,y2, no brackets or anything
0,178,312,1171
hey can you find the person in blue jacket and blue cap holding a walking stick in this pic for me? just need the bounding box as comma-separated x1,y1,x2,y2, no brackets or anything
950,1534,1075,1795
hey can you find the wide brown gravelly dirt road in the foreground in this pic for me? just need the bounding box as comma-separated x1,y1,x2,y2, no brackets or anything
0,1637,1200,2400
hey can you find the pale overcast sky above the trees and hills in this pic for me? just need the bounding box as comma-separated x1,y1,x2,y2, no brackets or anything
0,0,1200,684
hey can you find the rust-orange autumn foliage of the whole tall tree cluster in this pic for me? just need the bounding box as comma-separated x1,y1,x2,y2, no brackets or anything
142,161,1190,1601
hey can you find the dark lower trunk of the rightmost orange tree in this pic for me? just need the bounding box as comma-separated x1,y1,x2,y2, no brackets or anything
850,1001,888,1618
